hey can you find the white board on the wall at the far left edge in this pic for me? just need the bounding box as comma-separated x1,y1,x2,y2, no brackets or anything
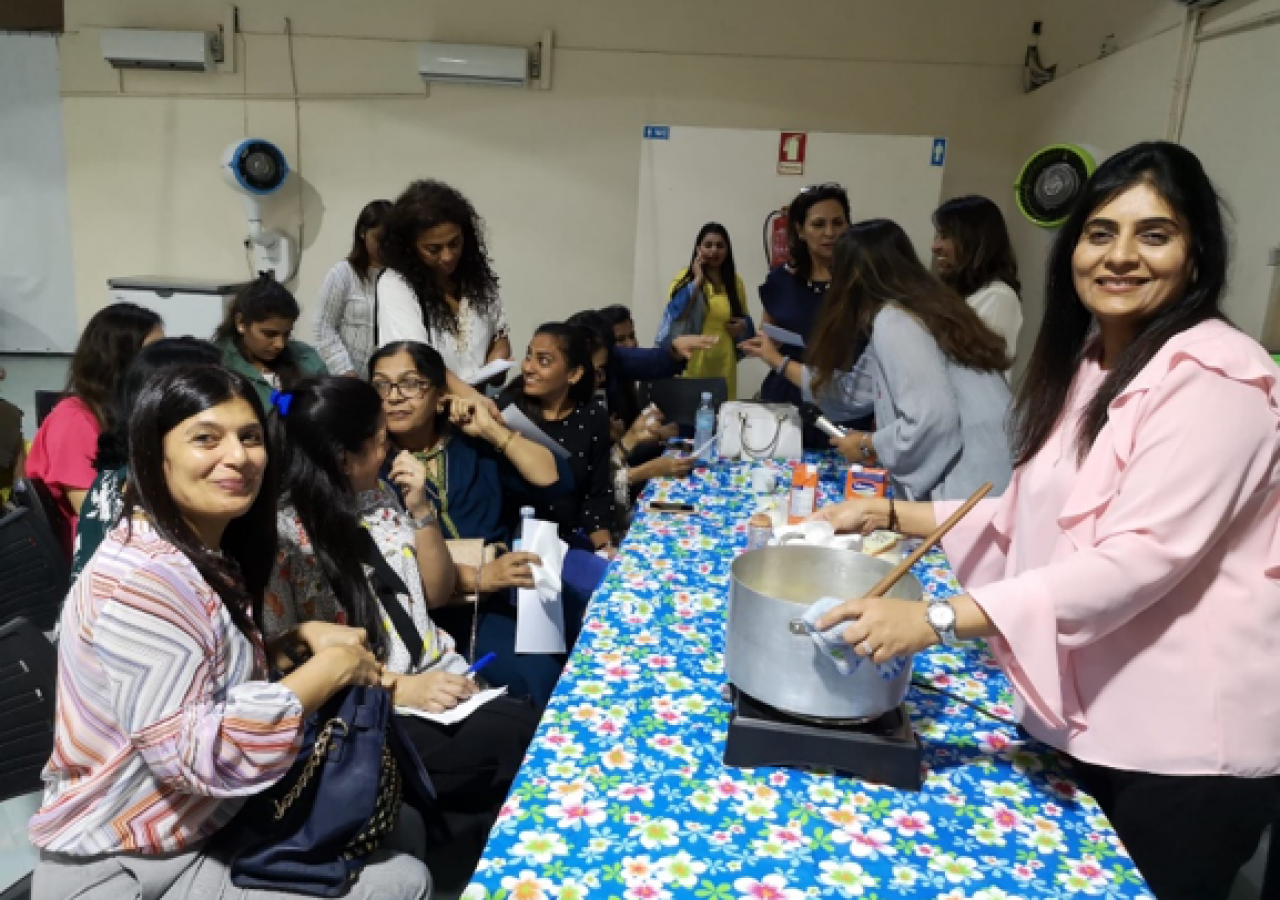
0,33,78,352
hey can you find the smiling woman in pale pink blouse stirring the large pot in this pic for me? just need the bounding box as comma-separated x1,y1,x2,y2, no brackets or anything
819,143,1280,900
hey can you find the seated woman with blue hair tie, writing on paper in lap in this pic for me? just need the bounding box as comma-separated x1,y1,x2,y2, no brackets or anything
264,376,538,887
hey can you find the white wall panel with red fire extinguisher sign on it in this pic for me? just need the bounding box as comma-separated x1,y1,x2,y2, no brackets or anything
631,125,946,397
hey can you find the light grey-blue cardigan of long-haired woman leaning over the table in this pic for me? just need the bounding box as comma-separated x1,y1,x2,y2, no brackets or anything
800,306,1012,501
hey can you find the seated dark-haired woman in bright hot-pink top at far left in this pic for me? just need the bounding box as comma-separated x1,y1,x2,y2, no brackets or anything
26,303,164,559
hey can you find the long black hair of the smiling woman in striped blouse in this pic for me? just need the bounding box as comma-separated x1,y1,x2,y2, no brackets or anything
123,365,279,644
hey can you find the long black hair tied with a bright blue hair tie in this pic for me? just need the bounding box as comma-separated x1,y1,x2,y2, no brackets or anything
272,375,387,658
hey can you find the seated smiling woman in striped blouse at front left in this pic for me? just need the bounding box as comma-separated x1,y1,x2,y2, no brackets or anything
31,366,430,900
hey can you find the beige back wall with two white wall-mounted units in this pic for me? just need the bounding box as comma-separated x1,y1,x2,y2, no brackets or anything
61,0,1032,346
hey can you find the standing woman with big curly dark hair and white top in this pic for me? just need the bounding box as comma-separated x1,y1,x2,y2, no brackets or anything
376,181,511,396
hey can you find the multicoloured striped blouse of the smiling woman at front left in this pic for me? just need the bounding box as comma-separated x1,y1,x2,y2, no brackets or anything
29,518,302,855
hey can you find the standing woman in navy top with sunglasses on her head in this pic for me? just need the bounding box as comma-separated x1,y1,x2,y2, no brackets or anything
760,184,849,447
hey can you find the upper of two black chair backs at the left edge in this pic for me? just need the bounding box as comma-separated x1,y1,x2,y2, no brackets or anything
0,490,70,631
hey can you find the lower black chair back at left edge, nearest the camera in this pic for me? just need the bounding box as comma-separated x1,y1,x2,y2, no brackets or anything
0,618,58,900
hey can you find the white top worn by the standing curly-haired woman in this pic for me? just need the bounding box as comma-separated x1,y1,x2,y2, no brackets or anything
378,269,508,384
